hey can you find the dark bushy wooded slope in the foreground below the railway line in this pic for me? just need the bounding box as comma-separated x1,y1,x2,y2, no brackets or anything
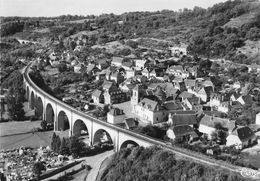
101,147,250,181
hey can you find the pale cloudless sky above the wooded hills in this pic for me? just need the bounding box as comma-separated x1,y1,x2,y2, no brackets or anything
0,0,226,17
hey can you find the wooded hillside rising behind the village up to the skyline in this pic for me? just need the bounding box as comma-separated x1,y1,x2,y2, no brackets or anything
1,0,260,64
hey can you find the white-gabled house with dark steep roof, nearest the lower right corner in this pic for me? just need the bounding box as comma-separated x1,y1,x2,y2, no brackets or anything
226,126,257,149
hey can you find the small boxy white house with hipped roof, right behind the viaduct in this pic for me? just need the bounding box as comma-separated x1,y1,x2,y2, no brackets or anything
107,108,125,124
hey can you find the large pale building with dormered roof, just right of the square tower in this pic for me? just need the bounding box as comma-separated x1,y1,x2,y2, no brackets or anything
133,98,167,124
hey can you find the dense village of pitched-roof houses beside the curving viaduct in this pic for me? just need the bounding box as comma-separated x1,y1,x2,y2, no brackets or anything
31,35,260,168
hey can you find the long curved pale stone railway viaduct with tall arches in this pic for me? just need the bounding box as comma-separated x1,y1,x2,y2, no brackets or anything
24,64,164,151
